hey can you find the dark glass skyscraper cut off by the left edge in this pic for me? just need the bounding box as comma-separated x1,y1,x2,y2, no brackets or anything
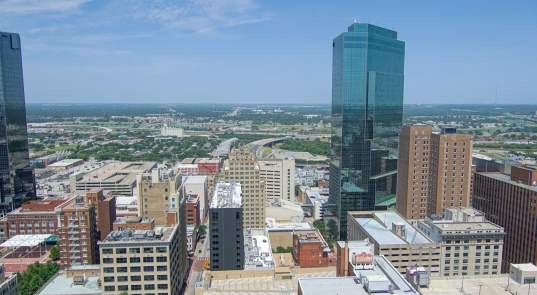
0,32,35,215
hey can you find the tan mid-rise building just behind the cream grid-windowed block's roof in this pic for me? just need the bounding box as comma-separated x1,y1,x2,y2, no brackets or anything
136,168,181,226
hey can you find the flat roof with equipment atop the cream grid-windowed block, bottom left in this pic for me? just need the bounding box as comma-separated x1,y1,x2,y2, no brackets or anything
99,225,178,246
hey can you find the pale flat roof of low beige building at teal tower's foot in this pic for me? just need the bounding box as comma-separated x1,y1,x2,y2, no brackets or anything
349,211,432,245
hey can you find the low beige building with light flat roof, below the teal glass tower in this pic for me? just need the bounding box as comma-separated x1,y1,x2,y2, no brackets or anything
347,211,440,275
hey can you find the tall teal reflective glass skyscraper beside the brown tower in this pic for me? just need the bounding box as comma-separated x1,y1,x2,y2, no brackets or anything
330,23,405,239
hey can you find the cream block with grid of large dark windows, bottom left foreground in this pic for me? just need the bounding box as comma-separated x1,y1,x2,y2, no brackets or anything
99,224,188,295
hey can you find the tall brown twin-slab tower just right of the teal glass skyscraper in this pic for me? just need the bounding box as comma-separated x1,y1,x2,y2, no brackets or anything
396,125,472,219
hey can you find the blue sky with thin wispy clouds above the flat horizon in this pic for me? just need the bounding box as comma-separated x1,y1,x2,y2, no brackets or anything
0,0,537,103
